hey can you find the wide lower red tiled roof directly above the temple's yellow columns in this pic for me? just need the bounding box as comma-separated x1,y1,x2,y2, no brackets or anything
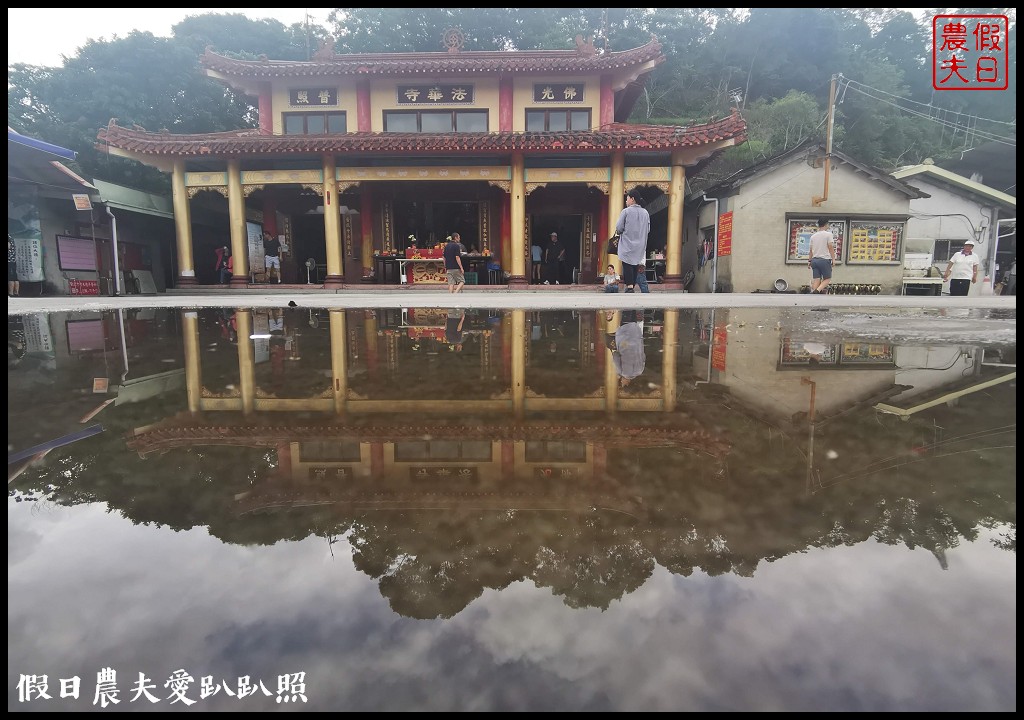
96,111,746,157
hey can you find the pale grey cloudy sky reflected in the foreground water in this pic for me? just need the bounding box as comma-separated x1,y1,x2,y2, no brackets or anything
8,506,1016,711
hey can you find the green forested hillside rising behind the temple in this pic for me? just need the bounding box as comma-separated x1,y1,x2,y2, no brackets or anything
7,8,1017,192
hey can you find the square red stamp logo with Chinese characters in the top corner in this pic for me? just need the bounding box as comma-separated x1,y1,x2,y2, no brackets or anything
932,15,1010,90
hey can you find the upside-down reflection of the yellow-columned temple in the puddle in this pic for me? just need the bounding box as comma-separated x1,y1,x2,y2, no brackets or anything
131,309,728,493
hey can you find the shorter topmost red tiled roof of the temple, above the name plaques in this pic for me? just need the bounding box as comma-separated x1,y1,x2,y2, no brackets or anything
200,38,665,80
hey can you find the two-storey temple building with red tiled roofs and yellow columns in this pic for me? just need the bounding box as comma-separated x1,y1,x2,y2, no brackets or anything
97,31,745,289
